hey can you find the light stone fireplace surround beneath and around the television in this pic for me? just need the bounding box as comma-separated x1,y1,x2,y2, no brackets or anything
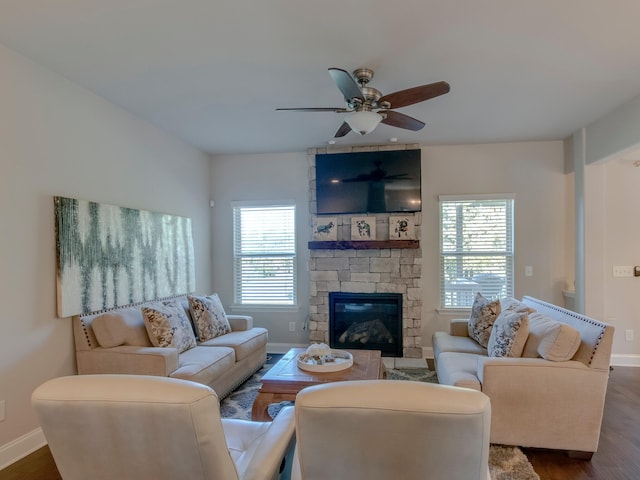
307,145,422,358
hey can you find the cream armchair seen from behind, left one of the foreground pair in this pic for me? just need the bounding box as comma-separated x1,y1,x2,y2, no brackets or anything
32,375,294,480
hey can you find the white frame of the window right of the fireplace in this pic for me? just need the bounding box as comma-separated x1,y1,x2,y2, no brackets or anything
438,193,515,312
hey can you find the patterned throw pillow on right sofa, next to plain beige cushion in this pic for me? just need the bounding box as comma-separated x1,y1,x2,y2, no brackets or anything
487,311,529,357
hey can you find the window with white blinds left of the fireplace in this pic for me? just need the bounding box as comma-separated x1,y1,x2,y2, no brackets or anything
233,204,296,306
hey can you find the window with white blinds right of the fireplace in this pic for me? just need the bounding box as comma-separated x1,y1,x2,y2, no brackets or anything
440,195,514,308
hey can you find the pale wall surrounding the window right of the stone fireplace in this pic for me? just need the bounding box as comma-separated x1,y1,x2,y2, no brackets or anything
421,141,568,346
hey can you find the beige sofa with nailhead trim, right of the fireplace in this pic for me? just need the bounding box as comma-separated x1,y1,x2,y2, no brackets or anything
433,297,614,458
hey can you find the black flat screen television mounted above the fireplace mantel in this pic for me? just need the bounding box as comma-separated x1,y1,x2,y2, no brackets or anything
316,149,422,215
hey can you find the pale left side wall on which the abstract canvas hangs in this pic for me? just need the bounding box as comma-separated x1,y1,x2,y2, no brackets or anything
0,46,211,462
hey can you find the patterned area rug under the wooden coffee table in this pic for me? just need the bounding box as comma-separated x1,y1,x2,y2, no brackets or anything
220,363,540,480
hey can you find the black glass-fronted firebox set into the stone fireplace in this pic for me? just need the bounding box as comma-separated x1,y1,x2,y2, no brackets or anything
329,292,402,357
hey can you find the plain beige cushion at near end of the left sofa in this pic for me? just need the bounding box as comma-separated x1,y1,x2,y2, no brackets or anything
91,308,152,348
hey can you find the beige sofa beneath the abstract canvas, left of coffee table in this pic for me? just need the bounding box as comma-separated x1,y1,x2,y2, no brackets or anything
73,297,268,398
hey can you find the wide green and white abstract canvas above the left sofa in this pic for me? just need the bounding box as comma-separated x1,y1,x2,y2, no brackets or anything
54,197,195,317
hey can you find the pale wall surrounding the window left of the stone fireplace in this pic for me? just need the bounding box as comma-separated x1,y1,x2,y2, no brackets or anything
211,152,311,352
